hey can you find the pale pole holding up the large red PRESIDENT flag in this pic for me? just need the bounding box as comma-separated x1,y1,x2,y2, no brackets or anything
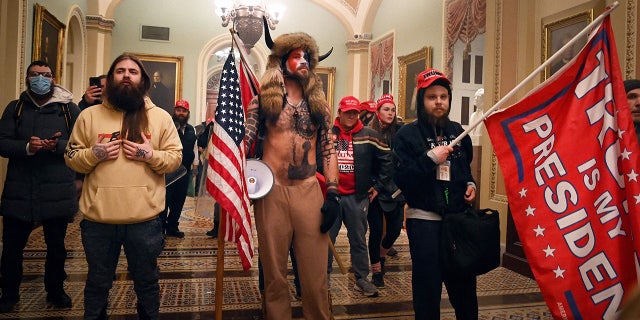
449,1,619,146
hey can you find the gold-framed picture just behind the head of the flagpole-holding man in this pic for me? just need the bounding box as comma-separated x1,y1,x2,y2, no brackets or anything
398,46,433,123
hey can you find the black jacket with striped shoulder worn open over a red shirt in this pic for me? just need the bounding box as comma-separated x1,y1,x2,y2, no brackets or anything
332,120,393,200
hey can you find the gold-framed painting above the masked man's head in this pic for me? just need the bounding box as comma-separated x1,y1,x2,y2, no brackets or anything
31,3,66,82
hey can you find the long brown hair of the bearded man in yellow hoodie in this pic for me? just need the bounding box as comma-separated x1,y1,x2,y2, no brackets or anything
107,53,151,143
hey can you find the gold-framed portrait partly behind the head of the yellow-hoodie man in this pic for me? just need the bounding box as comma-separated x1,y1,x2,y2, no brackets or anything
128,52,184,114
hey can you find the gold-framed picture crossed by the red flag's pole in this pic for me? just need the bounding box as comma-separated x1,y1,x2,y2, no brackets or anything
541,8,594,81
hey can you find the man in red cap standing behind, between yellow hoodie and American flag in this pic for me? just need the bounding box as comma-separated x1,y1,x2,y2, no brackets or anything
160,99,198,238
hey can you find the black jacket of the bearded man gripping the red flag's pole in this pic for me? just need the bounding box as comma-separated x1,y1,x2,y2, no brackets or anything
393,120,475,214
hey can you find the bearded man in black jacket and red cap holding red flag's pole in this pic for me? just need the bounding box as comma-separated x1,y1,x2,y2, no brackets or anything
393,69,478,320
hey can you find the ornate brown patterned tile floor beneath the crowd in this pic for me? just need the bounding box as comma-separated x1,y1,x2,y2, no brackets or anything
0,198,552,320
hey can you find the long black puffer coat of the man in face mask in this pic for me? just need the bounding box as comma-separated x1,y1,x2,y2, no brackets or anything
0,86,80,222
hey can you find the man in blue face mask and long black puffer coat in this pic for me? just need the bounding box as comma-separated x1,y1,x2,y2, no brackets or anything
0,61,80,313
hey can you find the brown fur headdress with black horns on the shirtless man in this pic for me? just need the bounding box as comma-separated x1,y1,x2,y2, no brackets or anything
260,17,333,124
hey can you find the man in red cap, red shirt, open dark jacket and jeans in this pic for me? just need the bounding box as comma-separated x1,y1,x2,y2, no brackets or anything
329,96,392,297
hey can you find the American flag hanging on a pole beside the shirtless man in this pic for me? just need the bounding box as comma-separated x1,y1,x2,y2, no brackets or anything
207,53,253,271
